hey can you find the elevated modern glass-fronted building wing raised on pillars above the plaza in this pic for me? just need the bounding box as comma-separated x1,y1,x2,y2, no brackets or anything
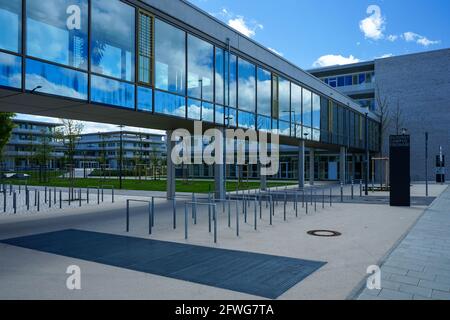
0,0,379,195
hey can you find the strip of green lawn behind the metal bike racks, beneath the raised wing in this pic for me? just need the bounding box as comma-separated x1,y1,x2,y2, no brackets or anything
3,175,294,193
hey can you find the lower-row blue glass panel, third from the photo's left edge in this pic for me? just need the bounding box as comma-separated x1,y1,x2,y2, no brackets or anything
91,75,134,109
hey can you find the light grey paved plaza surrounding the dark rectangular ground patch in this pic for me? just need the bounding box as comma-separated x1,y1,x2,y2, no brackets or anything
0,185,450,300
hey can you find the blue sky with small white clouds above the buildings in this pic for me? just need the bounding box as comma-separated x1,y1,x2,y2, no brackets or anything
190,0,450,69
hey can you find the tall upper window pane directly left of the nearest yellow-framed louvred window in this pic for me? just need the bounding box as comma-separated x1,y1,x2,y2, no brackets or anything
91,0,135,81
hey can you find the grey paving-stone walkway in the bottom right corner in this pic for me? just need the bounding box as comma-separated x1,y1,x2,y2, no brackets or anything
357,187,450,300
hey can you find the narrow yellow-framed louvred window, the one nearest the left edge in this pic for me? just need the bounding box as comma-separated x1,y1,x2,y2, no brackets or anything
138,12,153,84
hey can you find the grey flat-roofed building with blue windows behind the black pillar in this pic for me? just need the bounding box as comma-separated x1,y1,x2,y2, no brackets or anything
310,49,450,181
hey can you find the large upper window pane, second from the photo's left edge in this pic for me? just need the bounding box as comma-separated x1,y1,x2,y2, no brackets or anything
27,0,88,70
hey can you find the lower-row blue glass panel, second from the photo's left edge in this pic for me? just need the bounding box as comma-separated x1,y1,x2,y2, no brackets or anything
26,59,87,100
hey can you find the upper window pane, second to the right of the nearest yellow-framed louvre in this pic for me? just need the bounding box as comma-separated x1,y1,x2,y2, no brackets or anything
188,35,214,101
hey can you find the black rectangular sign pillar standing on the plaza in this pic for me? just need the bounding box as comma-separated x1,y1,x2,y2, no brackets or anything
389,135,411,207
